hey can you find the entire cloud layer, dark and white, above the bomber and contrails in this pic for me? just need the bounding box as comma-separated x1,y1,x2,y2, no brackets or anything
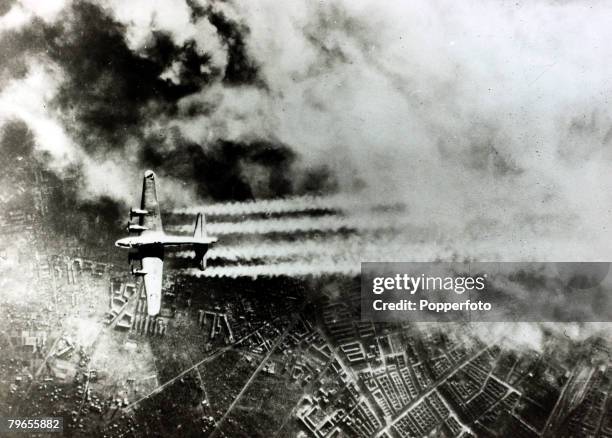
0,0,612,260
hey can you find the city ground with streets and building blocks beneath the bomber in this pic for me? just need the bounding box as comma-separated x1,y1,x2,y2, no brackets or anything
0,138,612,437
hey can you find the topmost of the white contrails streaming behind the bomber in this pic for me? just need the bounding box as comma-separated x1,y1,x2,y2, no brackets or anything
173,195,363,216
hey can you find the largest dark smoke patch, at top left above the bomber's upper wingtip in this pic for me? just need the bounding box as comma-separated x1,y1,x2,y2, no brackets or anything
1,2,215,151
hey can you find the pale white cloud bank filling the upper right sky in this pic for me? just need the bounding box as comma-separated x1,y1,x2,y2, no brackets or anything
203,0,612,260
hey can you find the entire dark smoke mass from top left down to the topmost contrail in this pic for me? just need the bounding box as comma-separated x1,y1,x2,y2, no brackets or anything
0,1,334,210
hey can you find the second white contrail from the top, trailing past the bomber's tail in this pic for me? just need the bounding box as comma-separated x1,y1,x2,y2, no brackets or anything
168,213,408,236
